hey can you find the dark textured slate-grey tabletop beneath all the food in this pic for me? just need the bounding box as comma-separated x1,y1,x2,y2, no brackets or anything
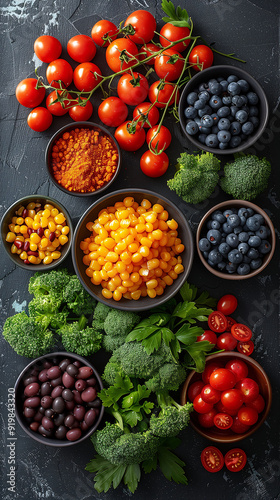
0,0,280,500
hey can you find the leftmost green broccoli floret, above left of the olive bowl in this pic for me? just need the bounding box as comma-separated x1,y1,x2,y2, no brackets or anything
3,312,54,358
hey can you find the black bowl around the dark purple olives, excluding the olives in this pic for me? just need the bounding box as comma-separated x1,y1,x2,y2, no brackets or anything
15,352,104,448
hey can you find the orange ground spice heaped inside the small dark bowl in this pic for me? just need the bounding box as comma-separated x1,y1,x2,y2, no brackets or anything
52,128,118,193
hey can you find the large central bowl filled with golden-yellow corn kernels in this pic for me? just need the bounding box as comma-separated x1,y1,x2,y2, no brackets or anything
72,188,194,311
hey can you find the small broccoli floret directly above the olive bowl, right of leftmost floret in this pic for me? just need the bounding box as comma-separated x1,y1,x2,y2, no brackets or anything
59,316,102,356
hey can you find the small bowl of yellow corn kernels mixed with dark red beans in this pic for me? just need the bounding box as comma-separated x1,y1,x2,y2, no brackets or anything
1,195,73,271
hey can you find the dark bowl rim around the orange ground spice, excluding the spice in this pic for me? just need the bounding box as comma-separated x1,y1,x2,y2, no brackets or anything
45,122,121,196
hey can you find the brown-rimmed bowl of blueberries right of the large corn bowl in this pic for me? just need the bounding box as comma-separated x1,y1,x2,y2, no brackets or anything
196,200,275,280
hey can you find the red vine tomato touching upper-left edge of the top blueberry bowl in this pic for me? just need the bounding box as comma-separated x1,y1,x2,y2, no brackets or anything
155,49,184,82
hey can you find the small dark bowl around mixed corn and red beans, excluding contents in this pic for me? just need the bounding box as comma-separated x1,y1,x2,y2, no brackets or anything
1,194,73,271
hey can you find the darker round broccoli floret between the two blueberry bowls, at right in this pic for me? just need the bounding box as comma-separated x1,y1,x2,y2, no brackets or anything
221,155,271,200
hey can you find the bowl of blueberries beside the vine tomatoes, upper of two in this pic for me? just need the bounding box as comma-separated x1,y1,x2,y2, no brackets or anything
179,66,269,154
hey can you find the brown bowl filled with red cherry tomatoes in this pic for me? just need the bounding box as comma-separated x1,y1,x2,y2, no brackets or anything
181,352,272,443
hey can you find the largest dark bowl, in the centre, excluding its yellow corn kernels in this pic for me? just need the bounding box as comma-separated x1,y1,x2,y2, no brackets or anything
72,188,194,311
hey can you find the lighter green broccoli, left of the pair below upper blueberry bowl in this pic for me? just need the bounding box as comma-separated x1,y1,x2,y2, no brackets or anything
167,153,220,203
